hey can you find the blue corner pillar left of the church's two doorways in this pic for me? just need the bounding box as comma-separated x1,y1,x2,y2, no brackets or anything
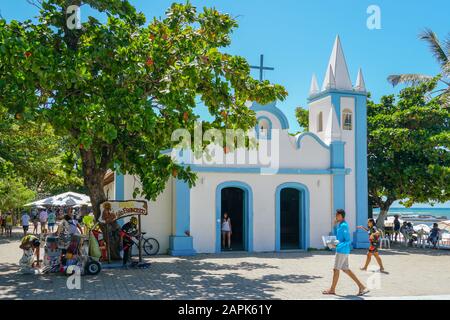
169,180,196,256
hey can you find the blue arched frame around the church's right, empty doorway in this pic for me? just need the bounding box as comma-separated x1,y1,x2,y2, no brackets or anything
275,182,309,251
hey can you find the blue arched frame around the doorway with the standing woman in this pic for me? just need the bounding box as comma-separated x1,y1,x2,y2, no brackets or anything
216,181,253,253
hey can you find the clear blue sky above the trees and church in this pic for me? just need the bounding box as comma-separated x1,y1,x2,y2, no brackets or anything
0,0,450,208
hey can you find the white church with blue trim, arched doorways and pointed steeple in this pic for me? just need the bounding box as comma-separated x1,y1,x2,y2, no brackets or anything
105,37,368,256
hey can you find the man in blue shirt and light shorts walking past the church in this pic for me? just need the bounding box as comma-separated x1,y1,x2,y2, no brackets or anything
322,209,369,296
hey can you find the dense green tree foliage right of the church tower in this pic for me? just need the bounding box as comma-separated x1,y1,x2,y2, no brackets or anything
368,79,450,210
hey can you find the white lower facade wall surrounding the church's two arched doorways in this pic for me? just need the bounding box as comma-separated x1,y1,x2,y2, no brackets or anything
191,173,332,253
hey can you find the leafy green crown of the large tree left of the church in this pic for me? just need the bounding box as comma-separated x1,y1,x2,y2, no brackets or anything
0,0,286,217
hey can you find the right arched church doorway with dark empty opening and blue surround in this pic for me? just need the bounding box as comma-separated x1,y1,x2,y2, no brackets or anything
275,183,309,251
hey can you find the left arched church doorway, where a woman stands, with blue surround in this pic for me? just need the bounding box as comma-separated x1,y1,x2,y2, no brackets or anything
216,182,253,252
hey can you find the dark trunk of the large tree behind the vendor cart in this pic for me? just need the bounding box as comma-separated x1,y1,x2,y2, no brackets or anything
80,149,121,260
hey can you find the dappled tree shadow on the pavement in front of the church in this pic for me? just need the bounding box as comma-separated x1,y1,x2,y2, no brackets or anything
0,258,321,300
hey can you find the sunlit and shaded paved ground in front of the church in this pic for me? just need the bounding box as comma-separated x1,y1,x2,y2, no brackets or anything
0,228,450,300
